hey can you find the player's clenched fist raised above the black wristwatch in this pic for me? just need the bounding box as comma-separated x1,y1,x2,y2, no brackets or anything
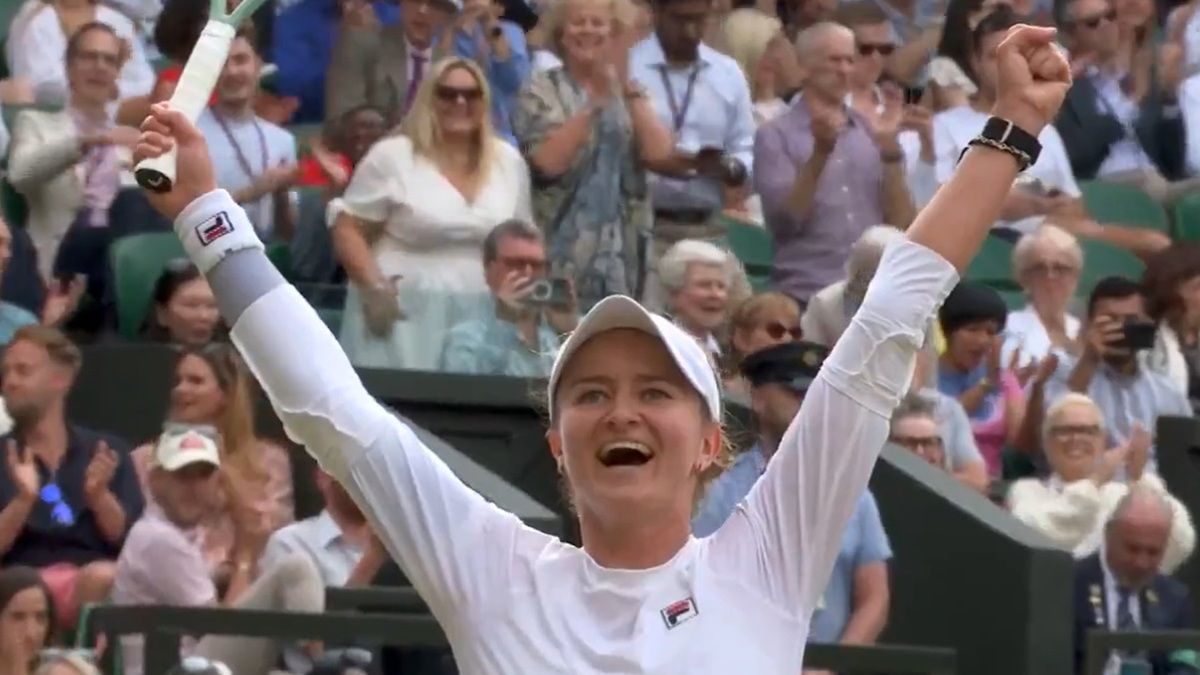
992,24,1070,136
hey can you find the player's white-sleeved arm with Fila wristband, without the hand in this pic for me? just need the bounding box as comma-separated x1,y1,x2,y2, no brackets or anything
175,190,540,621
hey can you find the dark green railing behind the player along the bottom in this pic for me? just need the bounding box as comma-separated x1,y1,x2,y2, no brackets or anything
91,587,958,675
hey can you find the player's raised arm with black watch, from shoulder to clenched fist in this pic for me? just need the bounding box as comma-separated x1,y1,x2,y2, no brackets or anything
715,25,1070,613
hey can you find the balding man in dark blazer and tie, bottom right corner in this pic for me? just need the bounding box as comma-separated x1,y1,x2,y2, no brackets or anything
1074,486,1200,675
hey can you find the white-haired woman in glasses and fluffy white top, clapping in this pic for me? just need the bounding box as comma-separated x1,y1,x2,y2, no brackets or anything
1008,393,1195,574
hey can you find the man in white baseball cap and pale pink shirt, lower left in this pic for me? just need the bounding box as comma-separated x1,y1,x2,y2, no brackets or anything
113,425,325,675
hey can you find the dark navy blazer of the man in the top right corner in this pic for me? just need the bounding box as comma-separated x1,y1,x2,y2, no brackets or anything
1055,76,1186,180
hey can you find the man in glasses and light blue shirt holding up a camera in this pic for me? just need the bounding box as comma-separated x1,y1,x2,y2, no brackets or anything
442,220,578,377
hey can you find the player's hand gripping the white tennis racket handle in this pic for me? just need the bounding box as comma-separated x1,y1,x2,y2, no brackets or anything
133,103,217,221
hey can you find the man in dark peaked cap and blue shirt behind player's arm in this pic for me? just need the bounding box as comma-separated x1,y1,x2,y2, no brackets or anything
692,341,892,658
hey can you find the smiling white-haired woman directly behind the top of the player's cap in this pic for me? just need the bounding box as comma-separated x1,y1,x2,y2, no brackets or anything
659,239,739,365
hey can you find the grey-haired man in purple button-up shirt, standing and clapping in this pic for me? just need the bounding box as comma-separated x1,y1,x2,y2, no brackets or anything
754,22,913,305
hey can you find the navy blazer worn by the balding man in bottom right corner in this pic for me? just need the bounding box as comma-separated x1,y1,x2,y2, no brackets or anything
1074,554,1200,675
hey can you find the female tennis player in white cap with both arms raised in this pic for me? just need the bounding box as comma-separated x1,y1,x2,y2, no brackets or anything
138,26,1070,675
